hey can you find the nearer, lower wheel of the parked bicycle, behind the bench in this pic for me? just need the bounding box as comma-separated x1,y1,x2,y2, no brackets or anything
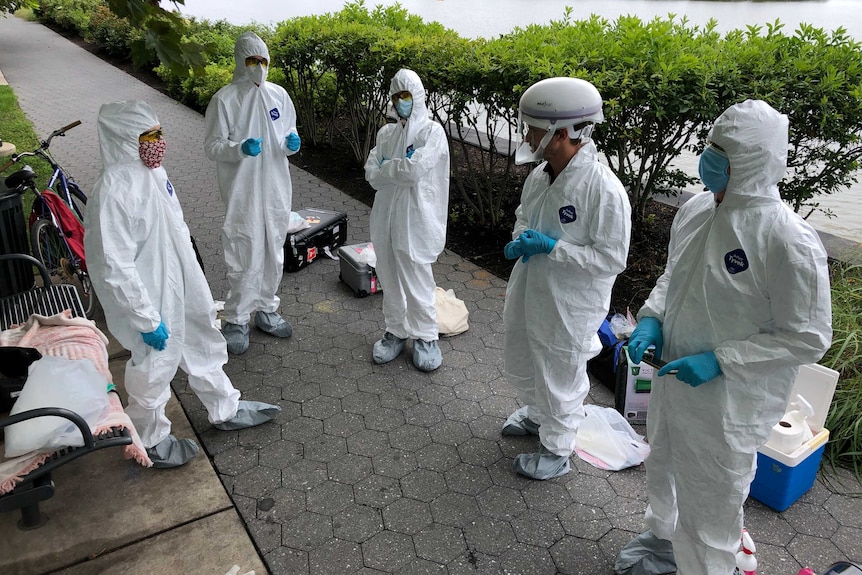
30,218,98,319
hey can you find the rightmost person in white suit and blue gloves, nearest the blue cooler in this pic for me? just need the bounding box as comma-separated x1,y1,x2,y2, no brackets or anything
616,100,832,575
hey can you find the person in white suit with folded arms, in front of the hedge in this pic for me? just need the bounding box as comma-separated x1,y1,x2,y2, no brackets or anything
365,69,449,371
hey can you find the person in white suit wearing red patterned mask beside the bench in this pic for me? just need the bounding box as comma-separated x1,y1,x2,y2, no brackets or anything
84,101,281,467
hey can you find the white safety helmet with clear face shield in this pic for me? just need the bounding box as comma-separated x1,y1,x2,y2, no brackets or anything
515,78,605,165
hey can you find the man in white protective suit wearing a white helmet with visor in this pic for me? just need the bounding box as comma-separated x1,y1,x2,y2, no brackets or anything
502,78,631,479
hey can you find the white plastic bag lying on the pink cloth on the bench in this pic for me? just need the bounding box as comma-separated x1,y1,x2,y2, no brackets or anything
6,355,111,457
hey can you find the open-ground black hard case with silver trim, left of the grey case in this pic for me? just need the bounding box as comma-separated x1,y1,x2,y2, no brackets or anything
284,208,347,272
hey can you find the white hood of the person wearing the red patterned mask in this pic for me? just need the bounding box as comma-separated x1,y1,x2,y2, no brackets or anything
98,100,159,168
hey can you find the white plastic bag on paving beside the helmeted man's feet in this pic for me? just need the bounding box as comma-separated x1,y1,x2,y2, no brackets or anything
575,405,649,471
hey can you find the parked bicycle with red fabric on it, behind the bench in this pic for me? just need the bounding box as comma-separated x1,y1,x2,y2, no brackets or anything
0,120,97,319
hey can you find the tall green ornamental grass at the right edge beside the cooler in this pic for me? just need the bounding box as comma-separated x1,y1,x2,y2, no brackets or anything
820,262,862,481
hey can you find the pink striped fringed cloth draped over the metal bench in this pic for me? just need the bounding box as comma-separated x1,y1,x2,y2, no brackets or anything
0,316,153,495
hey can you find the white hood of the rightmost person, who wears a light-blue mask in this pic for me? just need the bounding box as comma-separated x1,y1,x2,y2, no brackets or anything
709,100,789,200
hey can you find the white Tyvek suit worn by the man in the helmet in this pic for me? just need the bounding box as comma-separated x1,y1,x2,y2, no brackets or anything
506,140,631,456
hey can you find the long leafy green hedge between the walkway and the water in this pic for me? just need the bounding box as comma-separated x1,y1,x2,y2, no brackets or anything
35,0,862,231
